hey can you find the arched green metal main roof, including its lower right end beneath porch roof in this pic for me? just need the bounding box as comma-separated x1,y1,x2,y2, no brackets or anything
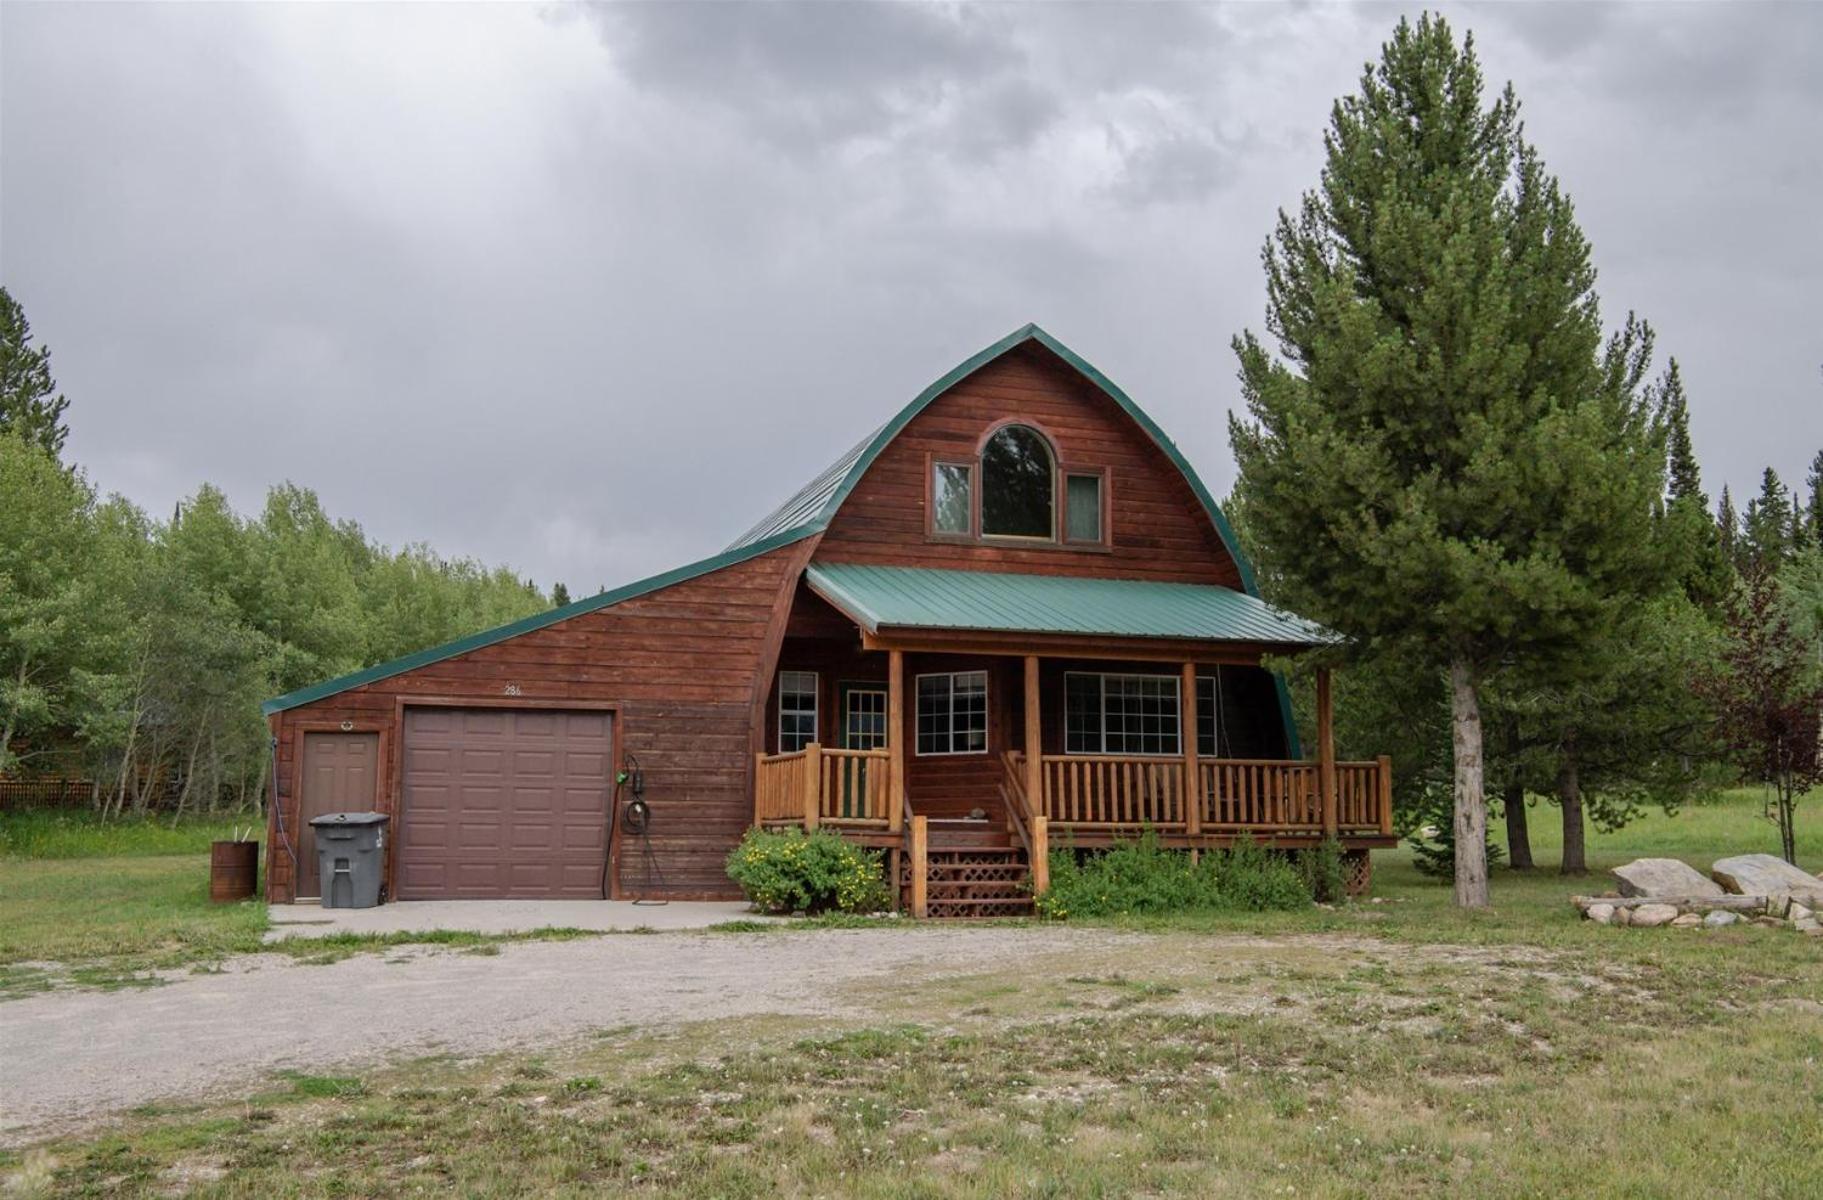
729,323,1303,747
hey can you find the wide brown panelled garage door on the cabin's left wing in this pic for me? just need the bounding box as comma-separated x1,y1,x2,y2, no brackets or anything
397,708,614,899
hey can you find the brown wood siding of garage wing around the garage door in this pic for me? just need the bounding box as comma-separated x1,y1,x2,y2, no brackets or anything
266,542,813,903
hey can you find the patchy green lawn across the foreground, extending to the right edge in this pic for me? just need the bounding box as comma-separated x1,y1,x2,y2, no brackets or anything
0,793,1823,1200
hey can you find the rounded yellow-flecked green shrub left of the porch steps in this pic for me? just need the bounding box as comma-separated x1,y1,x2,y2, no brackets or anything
727,830,891,912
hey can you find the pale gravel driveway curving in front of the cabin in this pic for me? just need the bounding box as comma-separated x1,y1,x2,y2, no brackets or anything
0,928,1125,1143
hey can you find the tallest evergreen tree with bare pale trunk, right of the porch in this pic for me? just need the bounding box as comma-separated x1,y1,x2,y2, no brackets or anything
1231,15,1664,906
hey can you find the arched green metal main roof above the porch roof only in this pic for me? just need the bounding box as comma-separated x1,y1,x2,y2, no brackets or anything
729,325,1260,596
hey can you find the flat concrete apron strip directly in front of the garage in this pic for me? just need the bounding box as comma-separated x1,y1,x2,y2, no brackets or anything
266,899,769,941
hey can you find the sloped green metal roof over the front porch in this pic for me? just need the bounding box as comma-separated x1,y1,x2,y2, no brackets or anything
804,562,1340,647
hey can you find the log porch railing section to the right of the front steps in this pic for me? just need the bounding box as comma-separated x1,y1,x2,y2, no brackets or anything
1003,750,1393,839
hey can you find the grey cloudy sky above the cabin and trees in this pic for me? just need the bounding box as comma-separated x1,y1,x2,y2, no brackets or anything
0,0,1823,593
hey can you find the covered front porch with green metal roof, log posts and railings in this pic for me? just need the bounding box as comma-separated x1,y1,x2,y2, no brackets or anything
753,564,1395,914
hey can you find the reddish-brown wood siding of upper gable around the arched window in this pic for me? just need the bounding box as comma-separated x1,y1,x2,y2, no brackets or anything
817,345,1241,587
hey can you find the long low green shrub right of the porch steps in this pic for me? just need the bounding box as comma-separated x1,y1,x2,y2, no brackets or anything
1037,833,1311,919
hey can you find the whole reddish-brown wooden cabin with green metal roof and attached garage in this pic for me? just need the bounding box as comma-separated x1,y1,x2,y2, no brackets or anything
266,326,1395,916
